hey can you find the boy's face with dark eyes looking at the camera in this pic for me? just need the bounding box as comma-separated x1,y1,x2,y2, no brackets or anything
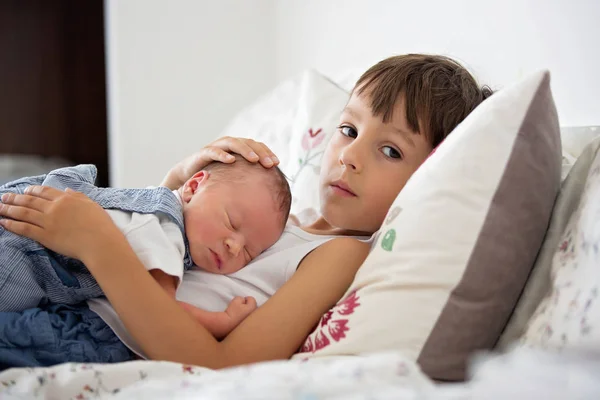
320,93,432,234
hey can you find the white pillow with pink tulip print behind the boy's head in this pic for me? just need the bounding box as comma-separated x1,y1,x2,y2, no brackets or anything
218,70,349,224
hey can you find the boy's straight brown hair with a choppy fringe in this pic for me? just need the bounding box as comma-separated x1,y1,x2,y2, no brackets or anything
354,54,492,147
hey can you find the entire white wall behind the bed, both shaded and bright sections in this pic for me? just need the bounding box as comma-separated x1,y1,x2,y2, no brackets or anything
105,0,600,186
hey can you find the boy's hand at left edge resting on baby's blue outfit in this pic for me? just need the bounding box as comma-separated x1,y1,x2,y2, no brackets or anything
0,186,122,263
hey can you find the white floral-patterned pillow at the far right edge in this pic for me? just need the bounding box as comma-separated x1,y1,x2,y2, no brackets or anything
522,141,600,349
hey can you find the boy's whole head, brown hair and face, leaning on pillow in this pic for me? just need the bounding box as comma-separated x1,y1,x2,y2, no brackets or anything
320,54,491,234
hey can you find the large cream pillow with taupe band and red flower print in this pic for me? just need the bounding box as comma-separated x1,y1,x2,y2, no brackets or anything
295,72,561,381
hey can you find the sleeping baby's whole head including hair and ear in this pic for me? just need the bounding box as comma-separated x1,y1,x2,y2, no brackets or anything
179,156,292,274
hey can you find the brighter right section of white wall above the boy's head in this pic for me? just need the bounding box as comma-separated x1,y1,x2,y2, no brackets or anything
275,0,600,125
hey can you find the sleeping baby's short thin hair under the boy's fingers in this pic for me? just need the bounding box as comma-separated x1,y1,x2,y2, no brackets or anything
203,154,292,226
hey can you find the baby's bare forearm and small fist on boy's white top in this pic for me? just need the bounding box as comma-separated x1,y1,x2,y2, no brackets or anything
178,296,256,339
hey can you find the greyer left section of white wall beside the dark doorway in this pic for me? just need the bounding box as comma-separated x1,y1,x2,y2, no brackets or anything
105,0,275,187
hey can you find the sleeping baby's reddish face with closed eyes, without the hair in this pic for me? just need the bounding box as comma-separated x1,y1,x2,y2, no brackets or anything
182,173,283,274
